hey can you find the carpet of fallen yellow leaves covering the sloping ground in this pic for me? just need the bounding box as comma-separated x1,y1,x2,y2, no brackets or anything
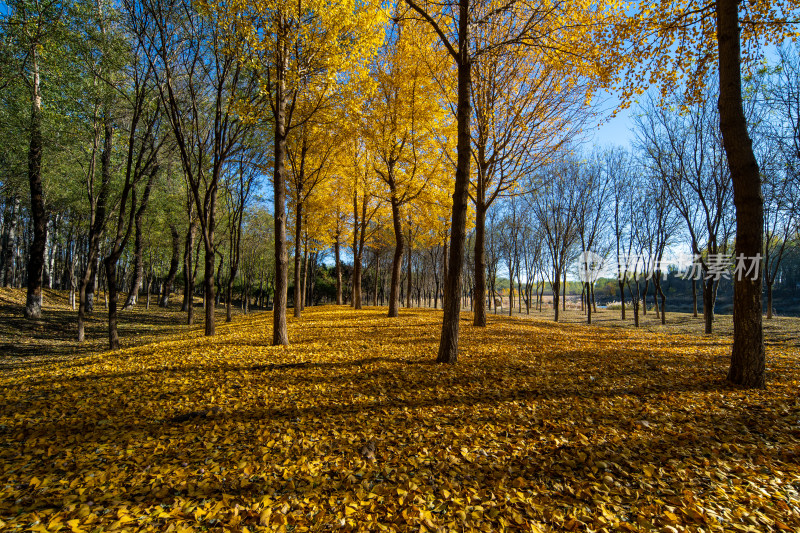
0,307,800,532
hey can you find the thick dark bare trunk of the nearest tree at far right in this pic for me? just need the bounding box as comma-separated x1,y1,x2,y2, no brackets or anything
716,0,766,388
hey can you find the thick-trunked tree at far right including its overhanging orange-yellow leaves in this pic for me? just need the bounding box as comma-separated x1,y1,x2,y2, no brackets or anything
613,0,798,388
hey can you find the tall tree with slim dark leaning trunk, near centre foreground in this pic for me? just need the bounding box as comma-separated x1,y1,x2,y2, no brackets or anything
405,0,624,363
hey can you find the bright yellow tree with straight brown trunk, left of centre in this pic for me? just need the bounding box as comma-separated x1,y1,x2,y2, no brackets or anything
215,0,386,345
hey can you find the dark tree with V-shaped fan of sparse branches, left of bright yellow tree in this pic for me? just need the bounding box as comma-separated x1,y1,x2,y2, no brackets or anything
125,0,259,335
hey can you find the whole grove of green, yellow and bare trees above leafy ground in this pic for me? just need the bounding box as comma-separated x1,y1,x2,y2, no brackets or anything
0,0,800,387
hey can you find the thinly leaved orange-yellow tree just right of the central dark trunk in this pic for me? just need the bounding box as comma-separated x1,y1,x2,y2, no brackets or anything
470,29,602,326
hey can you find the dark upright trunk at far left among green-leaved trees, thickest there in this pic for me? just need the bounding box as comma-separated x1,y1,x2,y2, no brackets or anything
25,50,47,319
